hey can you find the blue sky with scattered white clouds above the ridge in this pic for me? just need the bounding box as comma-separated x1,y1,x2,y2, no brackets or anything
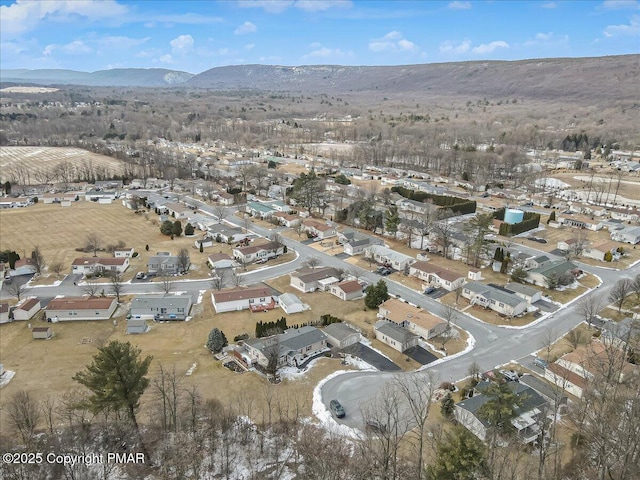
0,0,640,73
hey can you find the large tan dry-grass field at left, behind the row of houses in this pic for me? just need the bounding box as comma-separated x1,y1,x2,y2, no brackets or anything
0,201,218,280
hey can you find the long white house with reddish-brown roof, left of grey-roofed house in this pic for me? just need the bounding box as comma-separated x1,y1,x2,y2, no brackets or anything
45,297,118,322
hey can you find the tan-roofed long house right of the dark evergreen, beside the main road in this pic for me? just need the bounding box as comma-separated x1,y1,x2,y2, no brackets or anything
377,298,447,340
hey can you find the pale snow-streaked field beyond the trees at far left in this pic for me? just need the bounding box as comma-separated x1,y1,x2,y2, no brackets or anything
0,147,123,185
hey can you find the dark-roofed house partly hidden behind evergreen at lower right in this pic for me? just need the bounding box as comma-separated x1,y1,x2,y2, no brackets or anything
453,382,547,444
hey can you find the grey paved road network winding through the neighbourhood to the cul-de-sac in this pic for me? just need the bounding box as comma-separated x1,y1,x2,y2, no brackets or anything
15,201,640,427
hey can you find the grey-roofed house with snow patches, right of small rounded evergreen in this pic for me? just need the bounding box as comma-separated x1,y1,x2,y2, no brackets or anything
244,326,328,368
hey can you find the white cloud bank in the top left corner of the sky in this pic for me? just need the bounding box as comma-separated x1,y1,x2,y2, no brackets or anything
0,0,129,35
